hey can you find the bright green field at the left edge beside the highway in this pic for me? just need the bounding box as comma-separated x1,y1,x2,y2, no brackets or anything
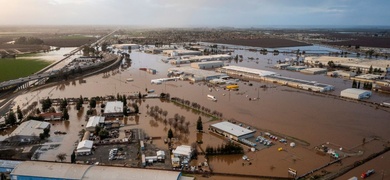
0,58,51,82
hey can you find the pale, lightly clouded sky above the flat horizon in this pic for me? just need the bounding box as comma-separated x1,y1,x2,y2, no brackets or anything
0,0,390,27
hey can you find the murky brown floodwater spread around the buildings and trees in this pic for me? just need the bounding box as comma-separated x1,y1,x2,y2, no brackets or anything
6,46,390,176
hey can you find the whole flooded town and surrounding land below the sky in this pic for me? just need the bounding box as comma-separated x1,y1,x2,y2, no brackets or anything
0,1,390,180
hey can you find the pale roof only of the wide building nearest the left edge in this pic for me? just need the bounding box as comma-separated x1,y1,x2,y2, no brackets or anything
10,120,50,136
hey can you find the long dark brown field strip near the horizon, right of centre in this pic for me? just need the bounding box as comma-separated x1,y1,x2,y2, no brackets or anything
209,38,311,48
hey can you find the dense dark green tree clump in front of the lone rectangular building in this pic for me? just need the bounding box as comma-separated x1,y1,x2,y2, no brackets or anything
205,142,244,155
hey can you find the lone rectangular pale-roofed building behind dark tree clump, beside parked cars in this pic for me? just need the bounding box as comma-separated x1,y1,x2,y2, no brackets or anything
210,121,255,141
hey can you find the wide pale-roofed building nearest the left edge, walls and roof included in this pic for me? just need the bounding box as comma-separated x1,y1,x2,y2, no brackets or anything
6,120,50,142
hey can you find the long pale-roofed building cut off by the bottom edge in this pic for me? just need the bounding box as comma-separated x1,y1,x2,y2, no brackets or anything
11,161,182,180
